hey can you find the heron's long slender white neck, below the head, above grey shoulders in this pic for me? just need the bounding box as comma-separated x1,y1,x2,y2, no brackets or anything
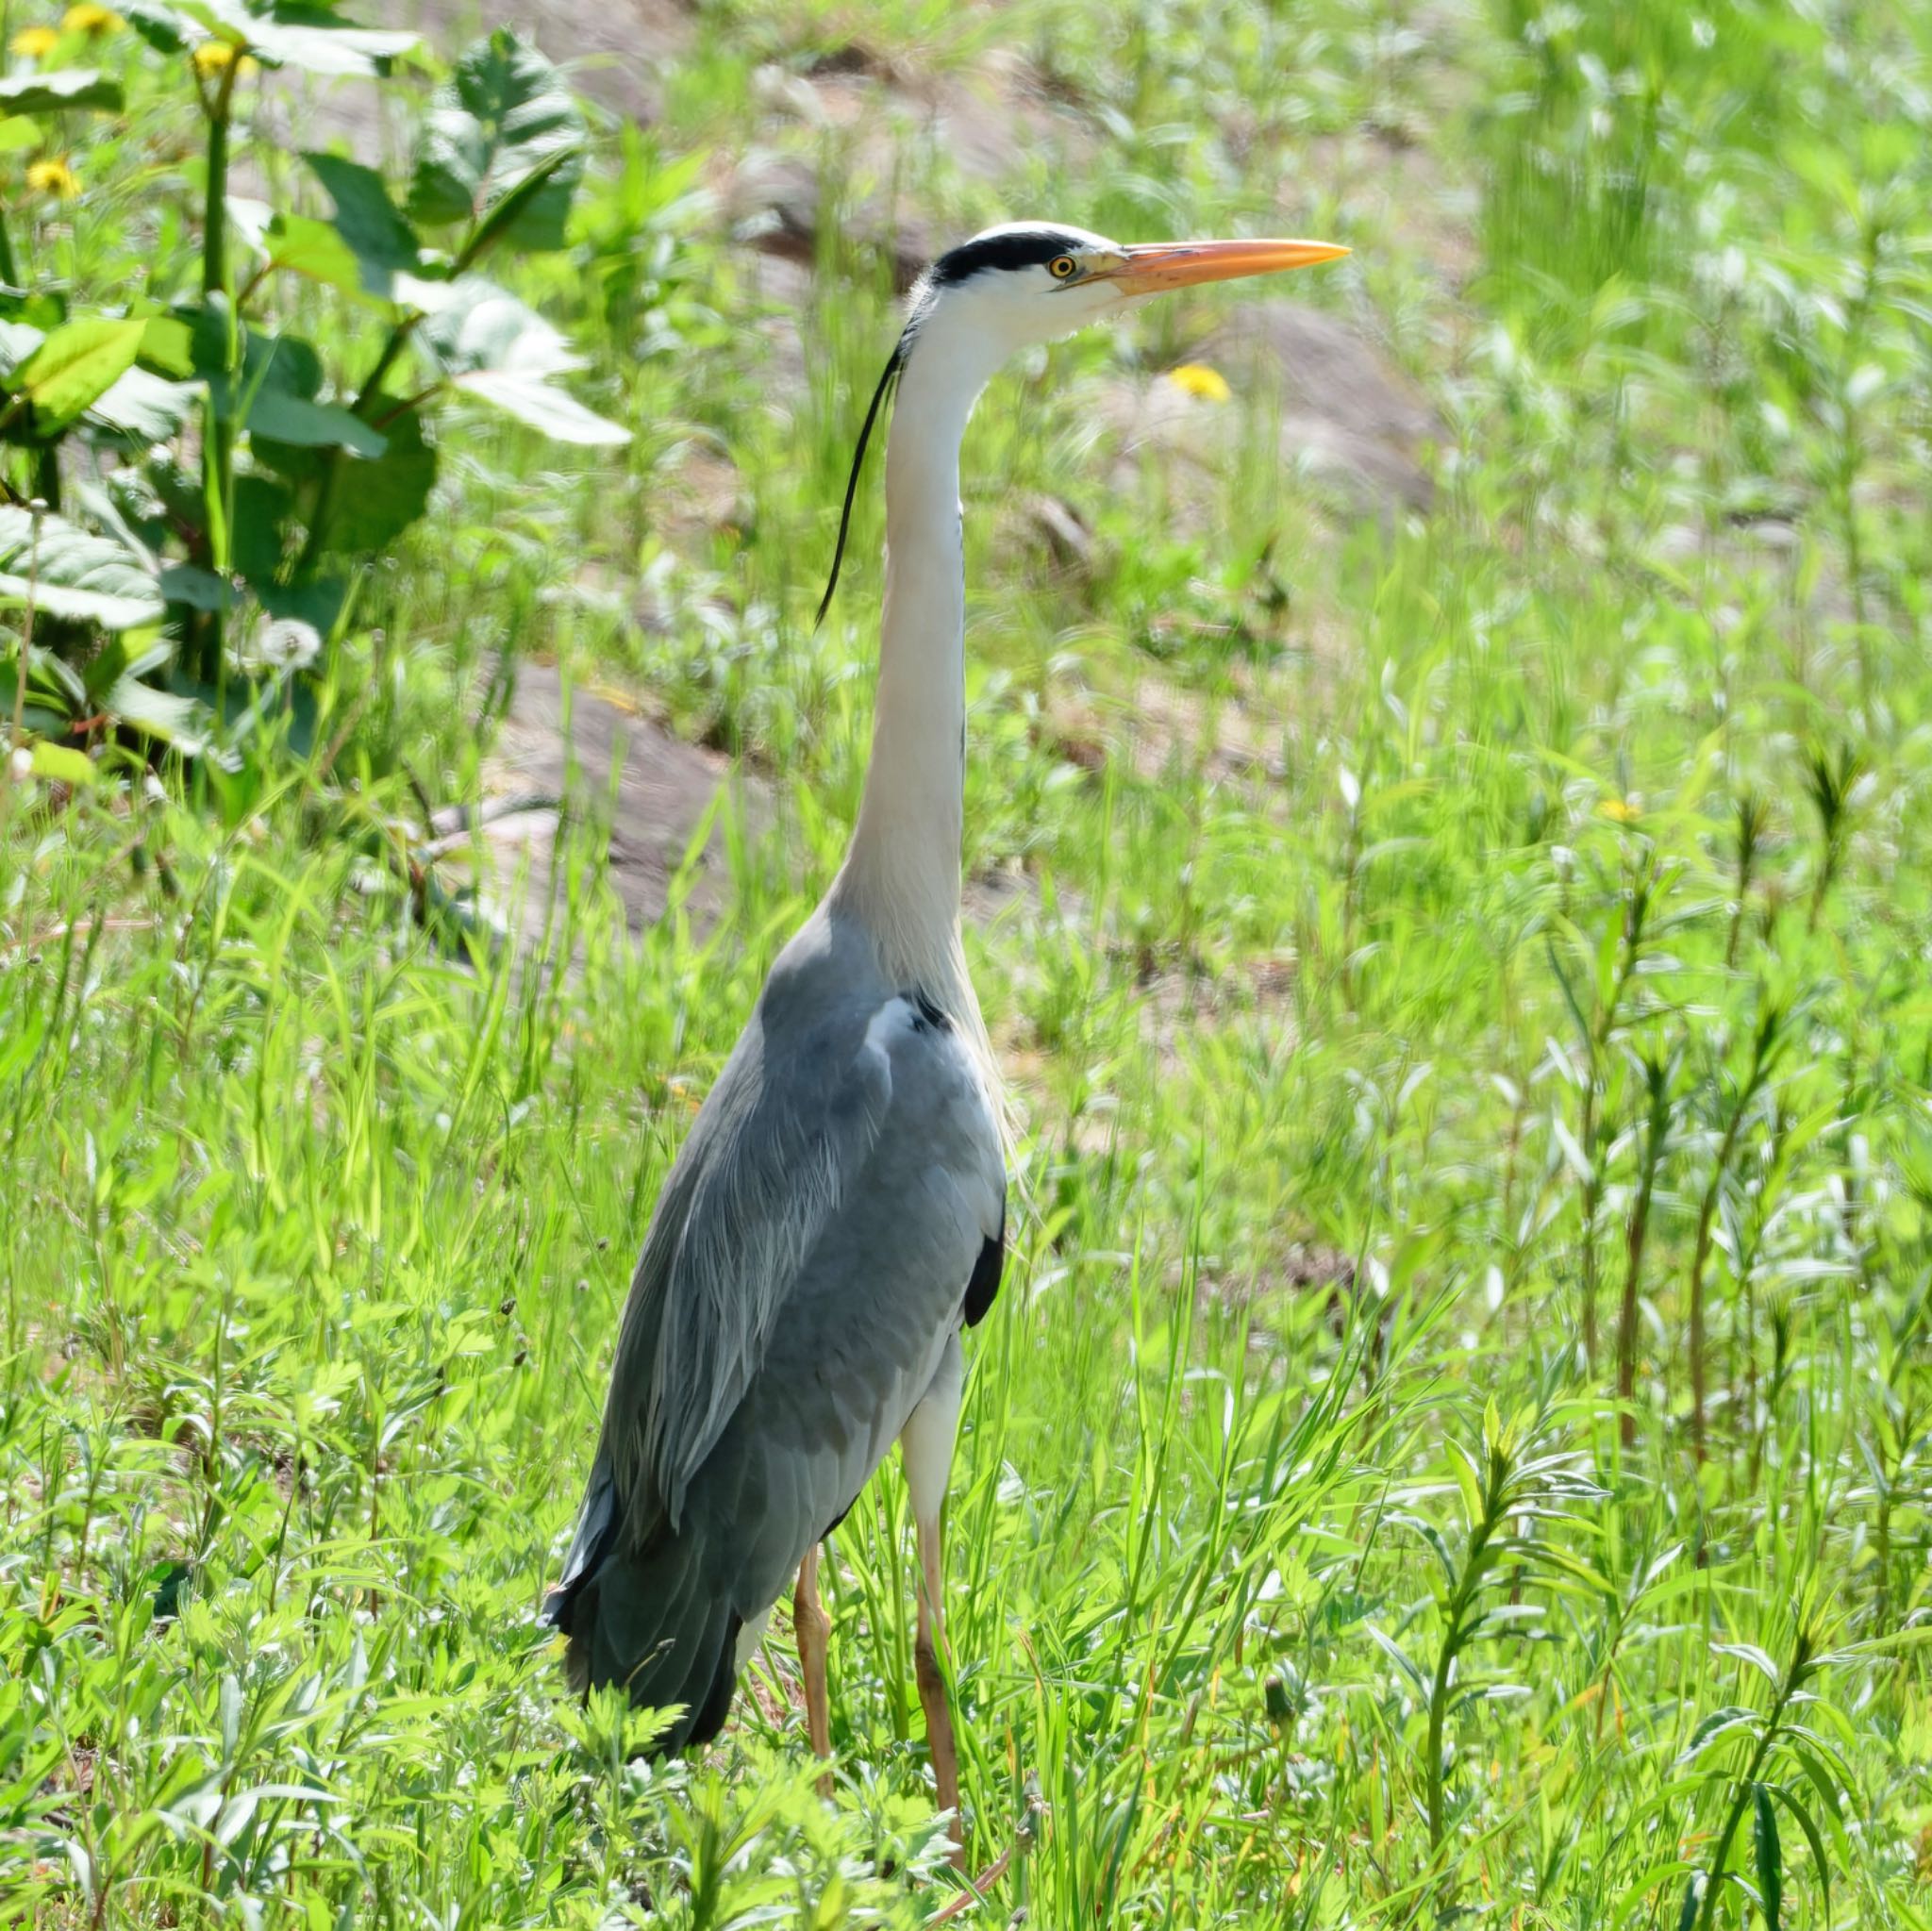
833,317,1005,1016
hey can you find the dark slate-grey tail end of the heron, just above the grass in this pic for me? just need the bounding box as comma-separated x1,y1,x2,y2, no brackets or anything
542,1457,741,1757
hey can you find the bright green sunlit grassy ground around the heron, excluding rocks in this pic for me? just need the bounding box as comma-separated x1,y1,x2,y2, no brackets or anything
0,0,1932,1931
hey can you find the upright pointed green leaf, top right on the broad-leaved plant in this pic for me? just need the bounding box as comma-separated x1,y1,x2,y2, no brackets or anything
409,29,583,253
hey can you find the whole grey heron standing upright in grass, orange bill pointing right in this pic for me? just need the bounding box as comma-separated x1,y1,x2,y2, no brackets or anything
545,222,1349,1840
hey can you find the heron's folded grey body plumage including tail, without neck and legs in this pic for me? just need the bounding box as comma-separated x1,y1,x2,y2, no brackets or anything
545,904,1005,1750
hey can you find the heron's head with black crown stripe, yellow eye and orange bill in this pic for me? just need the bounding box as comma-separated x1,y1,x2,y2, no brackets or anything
900,222,1349,365
